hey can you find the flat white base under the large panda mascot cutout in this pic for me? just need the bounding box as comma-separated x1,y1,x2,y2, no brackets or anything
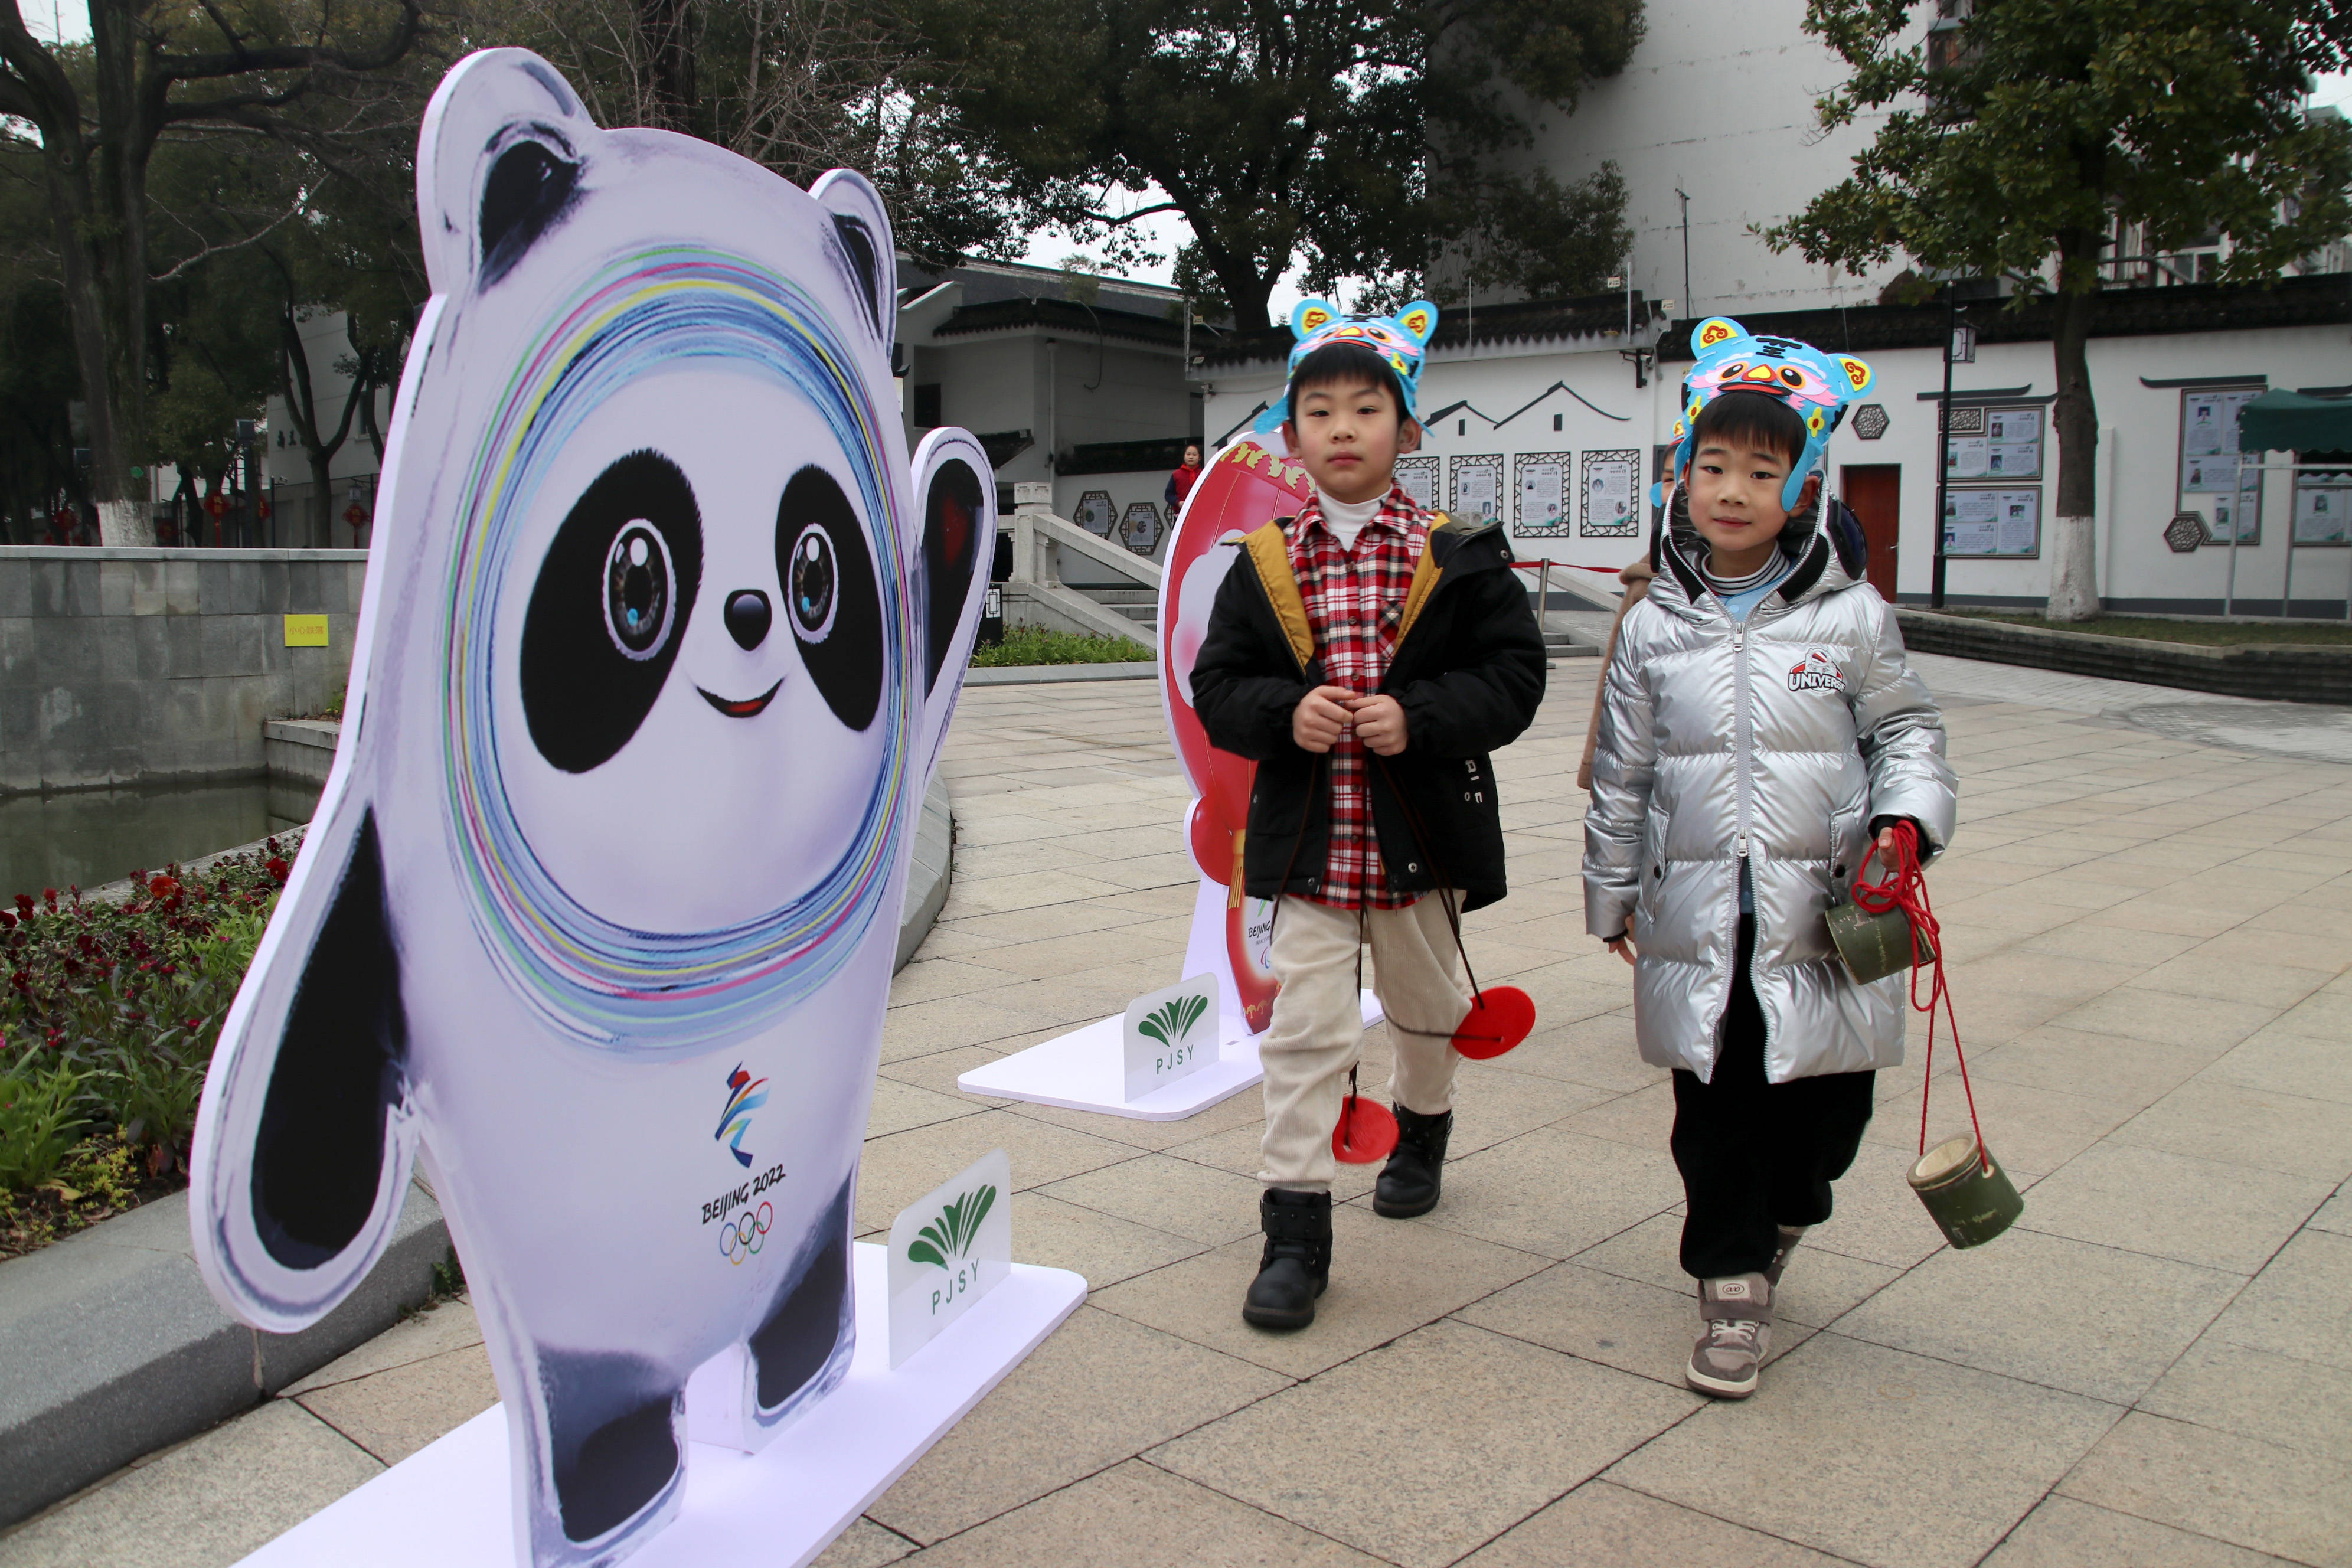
244,1242,1087,1568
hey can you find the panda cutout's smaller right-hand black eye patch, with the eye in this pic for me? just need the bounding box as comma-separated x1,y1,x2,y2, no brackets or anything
776,468,882,731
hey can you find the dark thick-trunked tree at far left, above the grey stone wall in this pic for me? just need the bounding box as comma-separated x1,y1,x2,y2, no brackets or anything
0,0,423,543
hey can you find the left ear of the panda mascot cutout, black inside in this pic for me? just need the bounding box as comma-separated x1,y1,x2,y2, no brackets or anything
416,50,597,294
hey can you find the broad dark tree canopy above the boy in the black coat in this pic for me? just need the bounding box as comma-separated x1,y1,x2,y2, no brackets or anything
910,0,1642,326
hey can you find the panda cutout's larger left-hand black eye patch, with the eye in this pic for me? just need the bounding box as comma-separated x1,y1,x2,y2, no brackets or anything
522,452,703,773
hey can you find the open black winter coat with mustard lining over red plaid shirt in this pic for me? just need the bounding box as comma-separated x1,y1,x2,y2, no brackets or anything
1193,512,1547,910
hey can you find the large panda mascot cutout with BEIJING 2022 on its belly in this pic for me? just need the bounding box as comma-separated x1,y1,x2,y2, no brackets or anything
191,50,995,1563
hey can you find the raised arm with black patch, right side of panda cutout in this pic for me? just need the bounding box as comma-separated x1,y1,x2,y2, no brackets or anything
913,426,997,778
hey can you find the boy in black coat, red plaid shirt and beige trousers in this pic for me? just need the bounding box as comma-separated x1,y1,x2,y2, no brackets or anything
1193,301,1545,1328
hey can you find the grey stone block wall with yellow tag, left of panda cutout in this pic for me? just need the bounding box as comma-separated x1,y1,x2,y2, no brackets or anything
0,545,367,795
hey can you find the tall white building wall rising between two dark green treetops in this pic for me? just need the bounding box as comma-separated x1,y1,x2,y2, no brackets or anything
1510,0,1933,318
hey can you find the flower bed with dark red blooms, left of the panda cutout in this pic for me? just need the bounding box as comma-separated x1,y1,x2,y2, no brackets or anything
0,835,299,1257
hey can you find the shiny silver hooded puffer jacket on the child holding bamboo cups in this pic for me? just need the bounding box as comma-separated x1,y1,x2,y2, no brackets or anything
1585,496,1957,1084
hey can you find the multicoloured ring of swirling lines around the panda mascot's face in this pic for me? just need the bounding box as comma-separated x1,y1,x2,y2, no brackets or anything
442,247,920,1056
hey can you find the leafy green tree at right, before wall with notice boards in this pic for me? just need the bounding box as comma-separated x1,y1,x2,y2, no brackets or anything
1764,0,2352,620
